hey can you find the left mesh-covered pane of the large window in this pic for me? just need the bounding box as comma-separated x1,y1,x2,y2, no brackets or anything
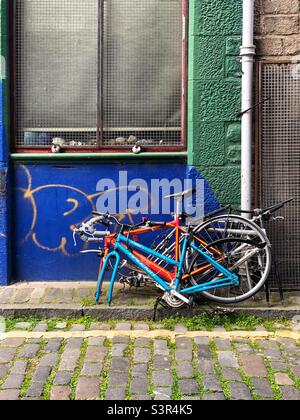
15,0,98,146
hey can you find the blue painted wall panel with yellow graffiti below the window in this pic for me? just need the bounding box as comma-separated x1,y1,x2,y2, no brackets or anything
13,163,218,281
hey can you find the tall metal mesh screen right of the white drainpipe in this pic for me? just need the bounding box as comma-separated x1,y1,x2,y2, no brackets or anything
261,64,300,289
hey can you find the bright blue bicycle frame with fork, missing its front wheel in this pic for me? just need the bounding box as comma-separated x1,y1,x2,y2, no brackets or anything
96,231,239,305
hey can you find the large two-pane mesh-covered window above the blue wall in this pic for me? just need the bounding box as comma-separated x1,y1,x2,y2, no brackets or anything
13,0,186,151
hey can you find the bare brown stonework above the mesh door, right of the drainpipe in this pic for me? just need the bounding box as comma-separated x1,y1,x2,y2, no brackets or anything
255,0,300,58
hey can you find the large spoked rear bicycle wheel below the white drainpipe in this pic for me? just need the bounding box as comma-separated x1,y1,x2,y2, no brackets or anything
189,215,271,303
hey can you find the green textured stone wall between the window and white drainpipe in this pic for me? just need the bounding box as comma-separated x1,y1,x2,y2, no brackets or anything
188,0,242,204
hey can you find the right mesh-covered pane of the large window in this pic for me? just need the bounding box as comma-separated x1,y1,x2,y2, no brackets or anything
104,0,182,145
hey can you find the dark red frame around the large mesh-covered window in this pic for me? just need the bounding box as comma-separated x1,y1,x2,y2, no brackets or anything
8,0,189,155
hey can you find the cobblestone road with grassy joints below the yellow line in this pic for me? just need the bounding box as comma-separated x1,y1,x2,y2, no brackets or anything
0,322,300,400
